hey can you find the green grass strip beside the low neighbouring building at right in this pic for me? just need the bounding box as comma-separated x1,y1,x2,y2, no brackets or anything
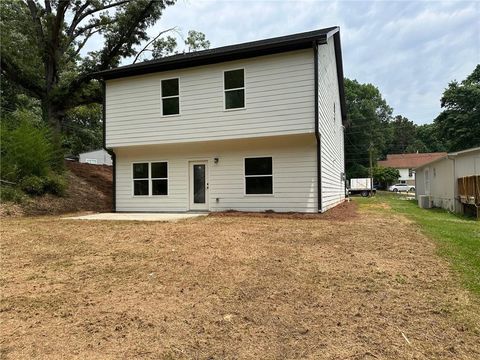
355,193,480,296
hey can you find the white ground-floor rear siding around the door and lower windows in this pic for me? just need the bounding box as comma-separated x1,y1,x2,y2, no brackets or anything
115,134,317,213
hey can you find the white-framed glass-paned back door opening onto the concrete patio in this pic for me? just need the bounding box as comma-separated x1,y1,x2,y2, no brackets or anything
188,161,208,210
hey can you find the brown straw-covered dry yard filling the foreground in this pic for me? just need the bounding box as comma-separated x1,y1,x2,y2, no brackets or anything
0,204,480,359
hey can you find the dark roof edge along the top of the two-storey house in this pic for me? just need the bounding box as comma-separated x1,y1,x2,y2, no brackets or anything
95,26,339,79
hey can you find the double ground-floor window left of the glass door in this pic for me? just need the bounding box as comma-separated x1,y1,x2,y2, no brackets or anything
133,161,168,196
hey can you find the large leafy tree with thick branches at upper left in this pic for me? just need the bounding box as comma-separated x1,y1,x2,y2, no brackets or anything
0,0,175,134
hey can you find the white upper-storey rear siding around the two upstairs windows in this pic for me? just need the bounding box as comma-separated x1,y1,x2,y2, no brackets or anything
106,49,314,147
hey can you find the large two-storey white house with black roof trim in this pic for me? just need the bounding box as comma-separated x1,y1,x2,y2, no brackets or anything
97,27,346,212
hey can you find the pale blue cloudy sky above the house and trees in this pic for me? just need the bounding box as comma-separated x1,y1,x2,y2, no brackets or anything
91,0,480,124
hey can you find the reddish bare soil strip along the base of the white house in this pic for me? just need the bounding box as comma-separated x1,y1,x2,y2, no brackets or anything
209,201,357,221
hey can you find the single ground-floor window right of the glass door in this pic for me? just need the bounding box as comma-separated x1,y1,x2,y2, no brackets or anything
245,157,273,195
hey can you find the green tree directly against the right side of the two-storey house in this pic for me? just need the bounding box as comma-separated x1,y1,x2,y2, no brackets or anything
345,79,392,173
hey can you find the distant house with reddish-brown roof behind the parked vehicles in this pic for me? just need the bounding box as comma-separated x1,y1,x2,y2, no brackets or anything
377,152,447,186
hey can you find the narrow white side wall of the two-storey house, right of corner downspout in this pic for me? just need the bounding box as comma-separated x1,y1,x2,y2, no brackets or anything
318,38,345,211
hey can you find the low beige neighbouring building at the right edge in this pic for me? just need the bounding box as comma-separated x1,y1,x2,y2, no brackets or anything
415,147,480,213
